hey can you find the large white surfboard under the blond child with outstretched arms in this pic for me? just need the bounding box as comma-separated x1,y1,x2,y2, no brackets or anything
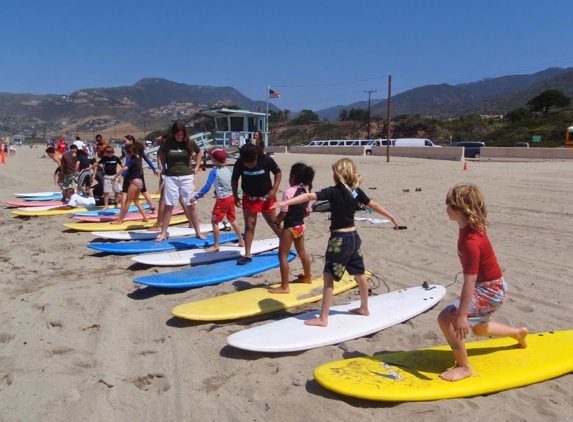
227,285,446,353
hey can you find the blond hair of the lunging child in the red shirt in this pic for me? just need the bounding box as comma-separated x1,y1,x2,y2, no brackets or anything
446,184,489,232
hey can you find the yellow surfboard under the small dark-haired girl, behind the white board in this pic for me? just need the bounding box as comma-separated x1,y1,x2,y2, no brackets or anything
171,272,364,321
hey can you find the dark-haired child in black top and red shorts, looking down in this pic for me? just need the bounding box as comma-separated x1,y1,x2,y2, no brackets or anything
231,144,281,265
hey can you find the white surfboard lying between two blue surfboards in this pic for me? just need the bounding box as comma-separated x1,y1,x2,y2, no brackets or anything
131,237,279,267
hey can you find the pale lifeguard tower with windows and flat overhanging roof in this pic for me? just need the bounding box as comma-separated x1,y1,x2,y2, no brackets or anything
203,108,268,148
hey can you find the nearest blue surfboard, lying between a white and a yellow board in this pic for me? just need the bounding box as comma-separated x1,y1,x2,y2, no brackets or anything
133,251,296,289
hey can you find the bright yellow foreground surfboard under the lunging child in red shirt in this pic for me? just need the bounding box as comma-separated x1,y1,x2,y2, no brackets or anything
314,327,573,401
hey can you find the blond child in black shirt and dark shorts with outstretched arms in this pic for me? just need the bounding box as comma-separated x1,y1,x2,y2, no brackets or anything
273,158,398,327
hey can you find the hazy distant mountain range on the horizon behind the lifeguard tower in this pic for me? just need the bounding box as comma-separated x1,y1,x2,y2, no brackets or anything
0,68,573,133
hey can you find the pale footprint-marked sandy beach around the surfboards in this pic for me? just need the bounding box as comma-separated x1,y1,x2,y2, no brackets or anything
0,146,573,422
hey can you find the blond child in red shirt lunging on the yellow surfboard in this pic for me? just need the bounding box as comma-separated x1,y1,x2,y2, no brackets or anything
438,185,528,381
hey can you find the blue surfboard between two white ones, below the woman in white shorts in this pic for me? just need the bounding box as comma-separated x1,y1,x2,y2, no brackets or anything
88,233,239,255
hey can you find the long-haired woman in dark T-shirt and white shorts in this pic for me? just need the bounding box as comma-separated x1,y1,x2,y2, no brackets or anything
156,122,205,242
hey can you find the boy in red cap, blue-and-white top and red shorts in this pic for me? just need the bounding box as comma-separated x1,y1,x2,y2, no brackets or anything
194,149,245,252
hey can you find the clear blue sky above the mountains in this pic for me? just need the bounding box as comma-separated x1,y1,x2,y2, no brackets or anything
0,0,573,111
